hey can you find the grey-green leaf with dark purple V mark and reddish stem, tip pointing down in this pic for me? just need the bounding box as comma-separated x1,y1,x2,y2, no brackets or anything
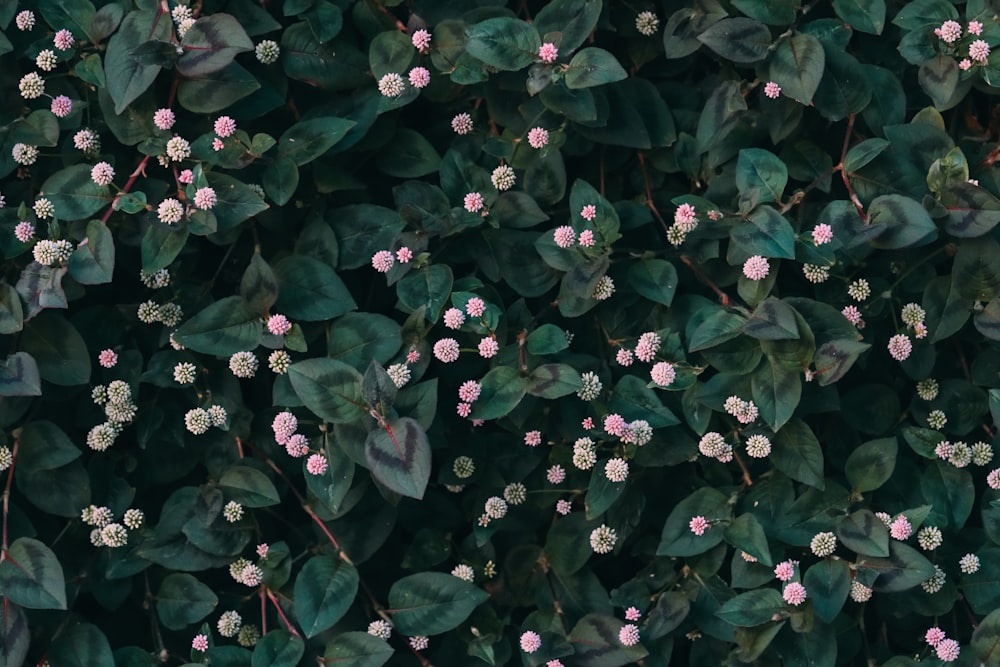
365,417,431,499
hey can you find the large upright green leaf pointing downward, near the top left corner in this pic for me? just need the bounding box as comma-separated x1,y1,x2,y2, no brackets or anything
105,11,173,113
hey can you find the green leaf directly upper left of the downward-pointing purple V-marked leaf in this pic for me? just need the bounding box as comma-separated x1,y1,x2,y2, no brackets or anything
288,358,364,424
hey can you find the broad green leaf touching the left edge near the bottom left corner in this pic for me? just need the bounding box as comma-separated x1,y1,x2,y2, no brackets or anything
0,537,66,609
